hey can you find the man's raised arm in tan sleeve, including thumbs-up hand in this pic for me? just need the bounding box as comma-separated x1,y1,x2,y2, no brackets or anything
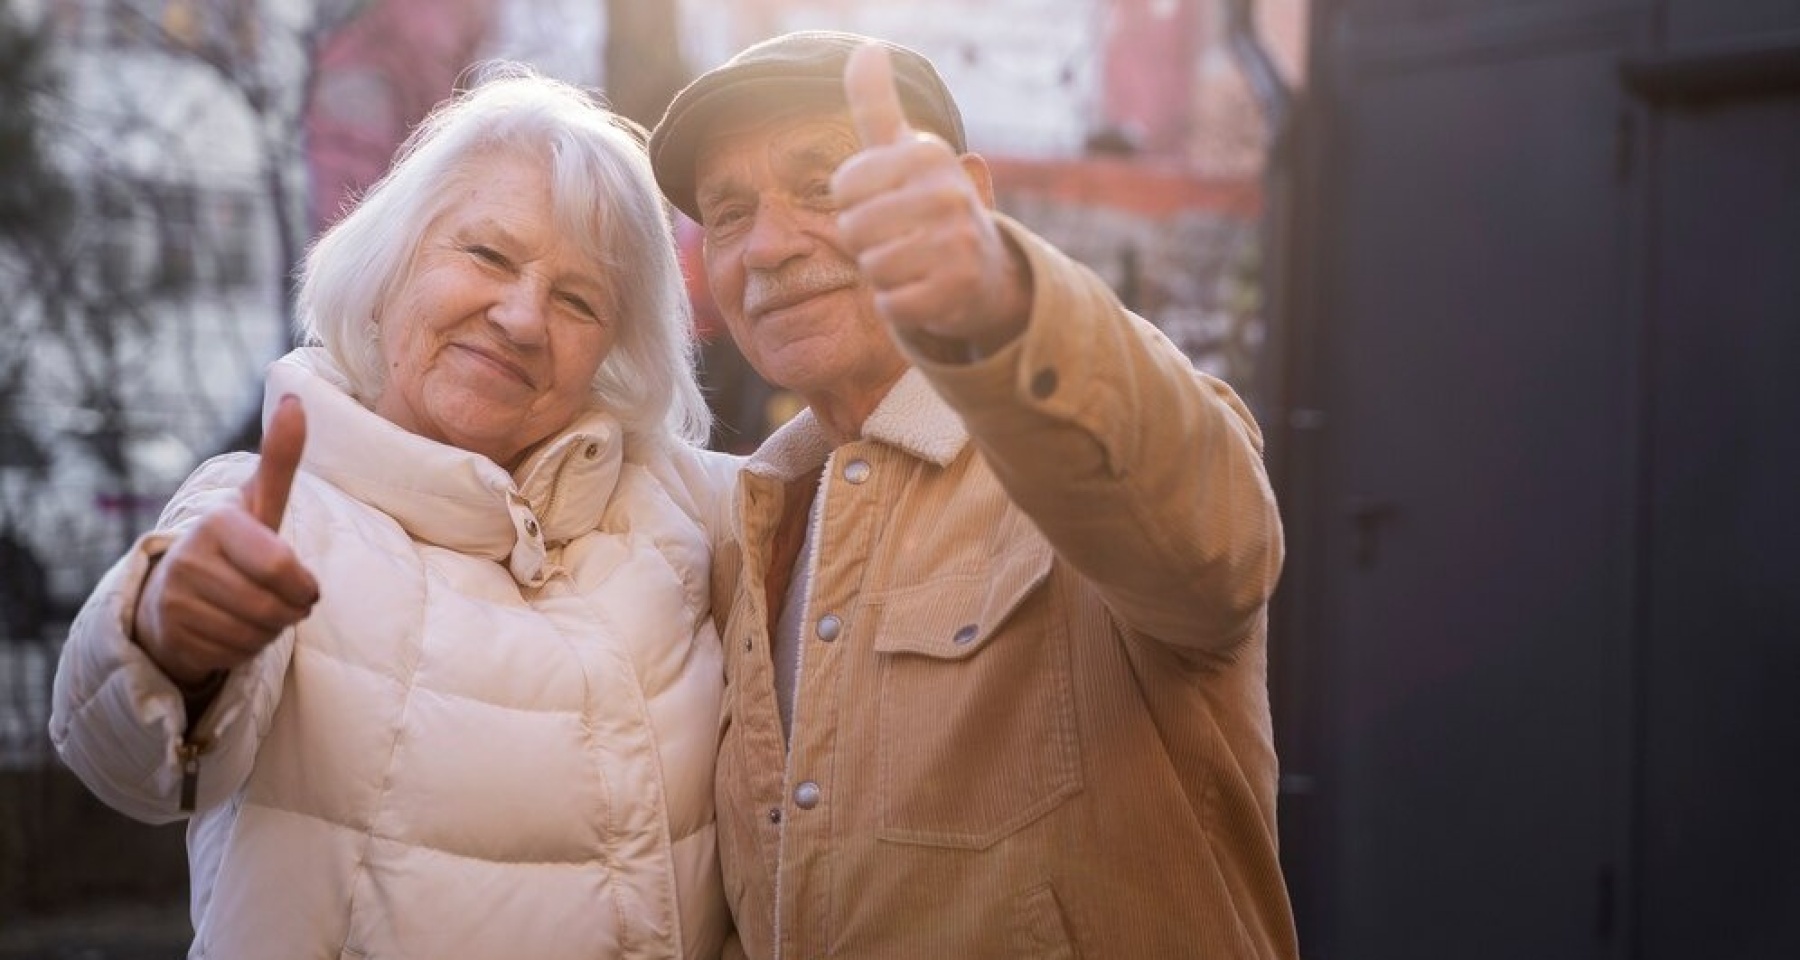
832,45,1282,654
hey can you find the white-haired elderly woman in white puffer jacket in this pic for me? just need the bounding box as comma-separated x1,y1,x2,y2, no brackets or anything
50,70,734,960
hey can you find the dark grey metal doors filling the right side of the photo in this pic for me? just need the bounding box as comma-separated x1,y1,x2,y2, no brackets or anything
1274,0,1800,960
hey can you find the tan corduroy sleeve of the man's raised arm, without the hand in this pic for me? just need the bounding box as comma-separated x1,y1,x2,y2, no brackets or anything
902,218,1282,654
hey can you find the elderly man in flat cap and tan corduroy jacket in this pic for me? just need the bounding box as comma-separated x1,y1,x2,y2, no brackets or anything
650,32,1296,960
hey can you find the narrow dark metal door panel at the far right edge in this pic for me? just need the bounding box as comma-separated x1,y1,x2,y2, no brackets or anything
1625,0,1800,960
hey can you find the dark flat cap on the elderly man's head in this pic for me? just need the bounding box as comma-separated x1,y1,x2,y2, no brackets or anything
650,31,968,220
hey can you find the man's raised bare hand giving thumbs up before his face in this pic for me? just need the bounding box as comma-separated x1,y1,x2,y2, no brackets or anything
832,43,1031,353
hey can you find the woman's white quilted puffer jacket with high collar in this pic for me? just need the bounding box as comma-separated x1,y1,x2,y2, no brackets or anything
50,349,734,960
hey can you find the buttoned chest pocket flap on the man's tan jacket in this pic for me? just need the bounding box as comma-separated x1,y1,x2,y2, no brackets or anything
875,540,1055,659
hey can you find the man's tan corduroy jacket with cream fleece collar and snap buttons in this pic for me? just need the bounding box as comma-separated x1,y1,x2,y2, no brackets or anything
715,222,1296,960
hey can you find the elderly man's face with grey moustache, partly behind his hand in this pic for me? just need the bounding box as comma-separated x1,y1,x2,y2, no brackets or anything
695,112,905,405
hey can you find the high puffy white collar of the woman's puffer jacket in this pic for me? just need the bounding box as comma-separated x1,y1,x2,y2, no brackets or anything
263,348,625,585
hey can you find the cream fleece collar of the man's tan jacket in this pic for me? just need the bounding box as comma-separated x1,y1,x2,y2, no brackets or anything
745,367,968,481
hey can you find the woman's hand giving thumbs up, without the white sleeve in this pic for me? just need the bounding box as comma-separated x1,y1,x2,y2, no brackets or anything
133,396,319,688
